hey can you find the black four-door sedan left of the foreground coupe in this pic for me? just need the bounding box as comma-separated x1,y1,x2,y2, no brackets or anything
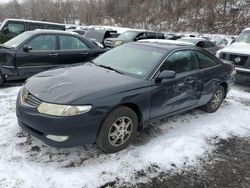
0,30,106,85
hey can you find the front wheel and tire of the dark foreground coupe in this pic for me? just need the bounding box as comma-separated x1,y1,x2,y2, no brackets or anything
96,106,138,153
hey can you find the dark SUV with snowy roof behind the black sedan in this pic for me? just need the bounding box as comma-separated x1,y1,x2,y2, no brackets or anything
0,19,65,44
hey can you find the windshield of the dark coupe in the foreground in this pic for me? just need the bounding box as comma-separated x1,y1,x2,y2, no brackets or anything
93,44,166,78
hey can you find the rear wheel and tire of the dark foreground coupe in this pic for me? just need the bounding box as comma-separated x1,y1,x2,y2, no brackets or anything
203,85,225,113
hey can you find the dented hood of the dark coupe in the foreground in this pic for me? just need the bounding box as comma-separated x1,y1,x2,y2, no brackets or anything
24,63,139,104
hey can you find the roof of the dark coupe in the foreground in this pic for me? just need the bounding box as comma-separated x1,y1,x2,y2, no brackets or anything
134,41,198,51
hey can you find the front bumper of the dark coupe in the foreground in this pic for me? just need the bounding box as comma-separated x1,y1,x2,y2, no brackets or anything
16,92,102,148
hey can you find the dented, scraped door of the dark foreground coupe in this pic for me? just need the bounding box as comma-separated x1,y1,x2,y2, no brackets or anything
151,50,202,118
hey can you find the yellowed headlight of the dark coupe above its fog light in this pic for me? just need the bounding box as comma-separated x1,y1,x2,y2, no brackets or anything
37,102,92,116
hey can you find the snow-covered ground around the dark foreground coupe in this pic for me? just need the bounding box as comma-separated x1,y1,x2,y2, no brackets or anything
0,87,250,188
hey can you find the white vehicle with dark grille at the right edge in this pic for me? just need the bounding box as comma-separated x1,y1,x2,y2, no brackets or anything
216,28,250,83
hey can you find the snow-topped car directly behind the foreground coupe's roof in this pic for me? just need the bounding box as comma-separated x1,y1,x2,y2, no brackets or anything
177,37,221,55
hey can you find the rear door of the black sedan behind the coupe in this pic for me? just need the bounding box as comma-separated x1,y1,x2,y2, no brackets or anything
59,35,94,65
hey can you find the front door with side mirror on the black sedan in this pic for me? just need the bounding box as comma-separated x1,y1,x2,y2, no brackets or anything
16,34,58,78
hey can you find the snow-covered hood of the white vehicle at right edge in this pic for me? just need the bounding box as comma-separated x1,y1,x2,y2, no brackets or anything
221,42,250,55
